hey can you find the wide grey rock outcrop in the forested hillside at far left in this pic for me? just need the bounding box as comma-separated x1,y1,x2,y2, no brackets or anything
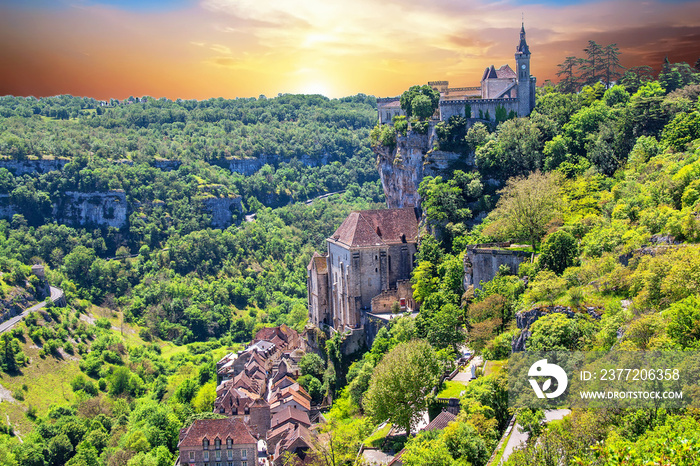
53,190,127,228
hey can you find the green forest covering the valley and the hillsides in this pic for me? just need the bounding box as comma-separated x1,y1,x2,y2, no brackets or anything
0,48,700,466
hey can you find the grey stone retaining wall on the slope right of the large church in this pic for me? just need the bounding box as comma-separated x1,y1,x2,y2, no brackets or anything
464,243,532,290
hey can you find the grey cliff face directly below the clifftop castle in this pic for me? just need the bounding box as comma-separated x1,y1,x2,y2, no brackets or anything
372,124,474,209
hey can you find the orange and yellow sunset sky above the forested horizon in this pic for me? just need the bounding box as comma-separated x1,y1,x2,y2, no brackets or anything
0,0,700,99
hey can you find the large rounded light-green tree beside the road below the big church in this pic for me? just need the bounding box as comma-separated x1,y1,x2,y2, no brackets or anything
363,340,440,435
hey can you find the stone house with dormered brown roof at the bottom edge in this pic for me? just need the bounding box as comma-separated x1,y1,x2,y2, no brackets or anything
177,418,258,466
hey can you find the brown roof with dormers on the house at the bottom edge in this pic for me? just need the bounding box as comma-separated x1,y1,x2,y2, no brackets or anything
178,417,257,448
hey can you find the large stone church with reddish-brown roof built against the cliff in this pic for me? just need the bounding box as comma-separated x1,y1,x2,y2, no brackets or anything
307,207,418,332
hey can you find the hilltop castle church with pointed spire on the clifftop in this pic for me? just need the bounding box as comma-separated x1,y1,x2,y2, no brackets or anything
377,24,536,124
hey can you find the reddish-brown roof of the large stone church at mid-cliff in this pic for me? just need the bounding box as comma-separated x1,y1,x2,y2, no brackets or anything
329,207,418,247
